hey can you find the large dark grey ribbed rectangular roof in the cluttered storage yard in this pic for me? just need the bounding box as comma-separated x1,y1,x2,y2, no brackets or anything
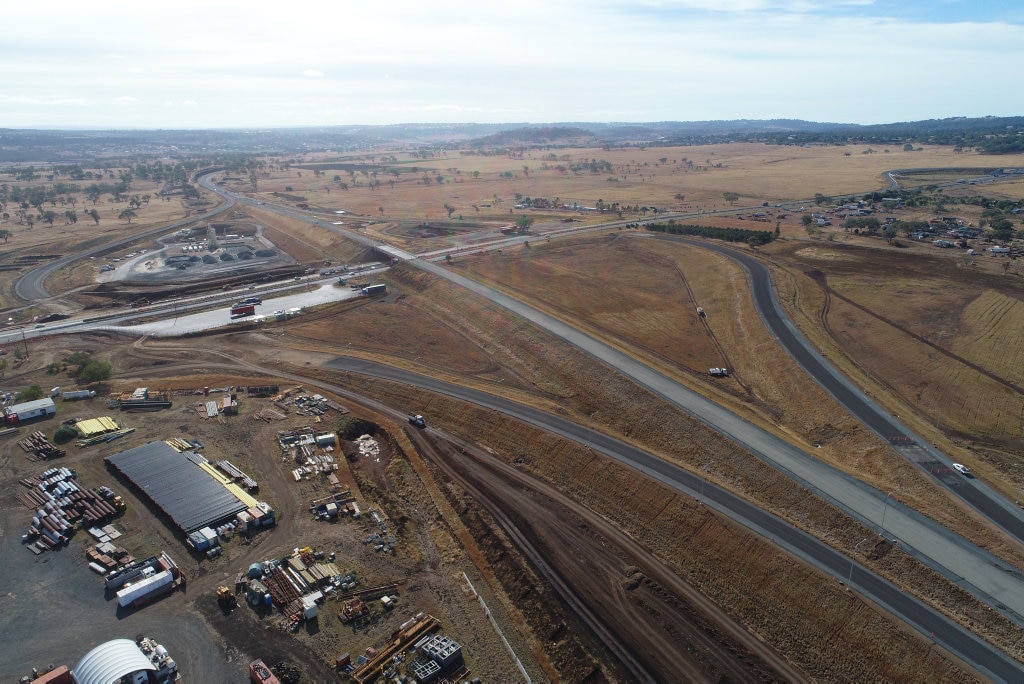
103,441,249,535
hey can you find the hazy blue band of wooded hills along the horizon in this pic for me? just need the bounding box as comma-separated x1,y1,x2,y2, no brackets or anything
0,117,1024,164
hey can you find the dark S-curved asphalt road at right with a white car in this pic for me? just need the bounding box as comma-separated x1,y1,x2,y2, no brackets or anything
658,237,1024,542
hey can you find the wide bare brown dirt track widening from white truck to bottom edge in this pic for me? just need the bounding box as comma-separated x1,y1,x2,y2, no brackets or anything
415,431,808,681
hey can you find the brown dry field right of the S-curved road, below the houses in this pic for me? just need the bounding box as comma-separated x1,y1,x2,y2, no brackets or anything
772,243,1024,485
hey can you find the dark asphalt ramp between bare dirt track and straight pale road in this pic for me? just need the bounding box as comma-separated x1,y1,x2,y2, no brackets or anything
325,357,1024,682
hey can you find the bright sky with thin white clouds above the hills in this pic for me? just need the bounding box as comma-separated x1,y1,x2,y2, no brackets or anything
0,0,1024,129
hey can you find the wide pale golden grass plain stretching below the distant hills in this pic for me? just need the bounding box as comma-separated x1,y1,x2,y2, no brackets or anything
237,143,1024,222
